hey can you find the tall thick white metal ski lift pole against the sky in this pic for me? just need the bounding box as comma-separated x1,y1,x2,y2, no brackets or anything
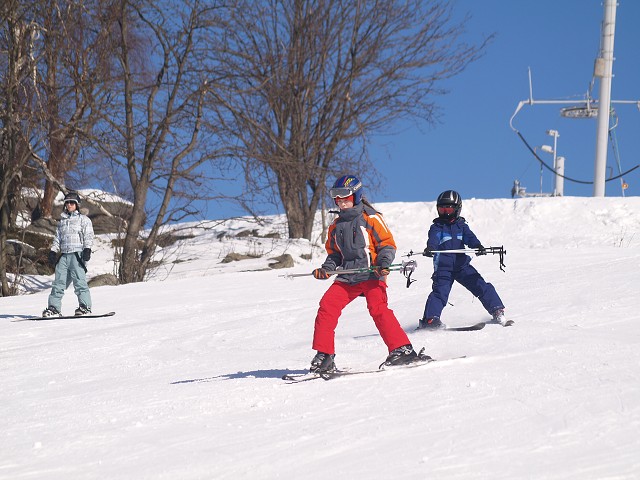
593,0,617,197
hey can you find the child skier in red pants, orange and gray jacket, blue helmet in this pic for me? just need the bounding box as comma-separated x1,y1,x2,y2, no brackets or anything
310,175,424,373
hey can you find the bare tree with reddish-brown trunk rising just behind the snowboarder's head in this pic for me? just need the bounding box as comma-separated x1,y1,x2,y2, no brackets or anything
33,0,114,218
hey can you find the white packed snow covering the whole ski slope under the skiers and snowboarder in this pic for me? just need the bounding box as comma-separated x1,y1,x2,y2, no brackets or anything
0,197,640,480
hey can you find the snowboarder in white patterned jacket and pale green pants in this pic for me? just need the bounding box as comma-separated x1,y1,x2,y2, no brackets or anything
42,192,94,317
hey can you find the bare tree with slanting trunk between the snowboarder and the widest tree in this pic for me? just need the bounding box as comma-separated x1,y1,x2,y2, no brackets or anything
107,0,228,283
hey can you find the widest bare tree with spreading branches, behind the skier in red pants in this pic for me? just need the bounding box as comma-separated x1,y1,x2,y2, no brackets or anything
213,0,489,239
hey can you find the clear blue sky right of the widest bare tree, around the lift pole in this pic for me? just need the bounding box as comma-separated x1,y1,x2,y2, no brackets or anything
369,0,640,206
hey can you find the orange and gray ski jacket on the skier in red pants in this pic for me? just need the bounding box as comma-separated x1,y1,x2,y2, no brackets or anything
322,203,396,284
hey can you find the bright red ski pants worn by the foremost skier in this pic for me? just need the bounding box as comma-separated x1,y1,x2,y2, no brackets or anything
312,280,411,354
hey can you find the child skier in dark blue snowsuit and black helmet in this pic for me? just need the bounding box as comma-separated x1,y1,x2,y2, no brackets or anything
418,190,506,329
